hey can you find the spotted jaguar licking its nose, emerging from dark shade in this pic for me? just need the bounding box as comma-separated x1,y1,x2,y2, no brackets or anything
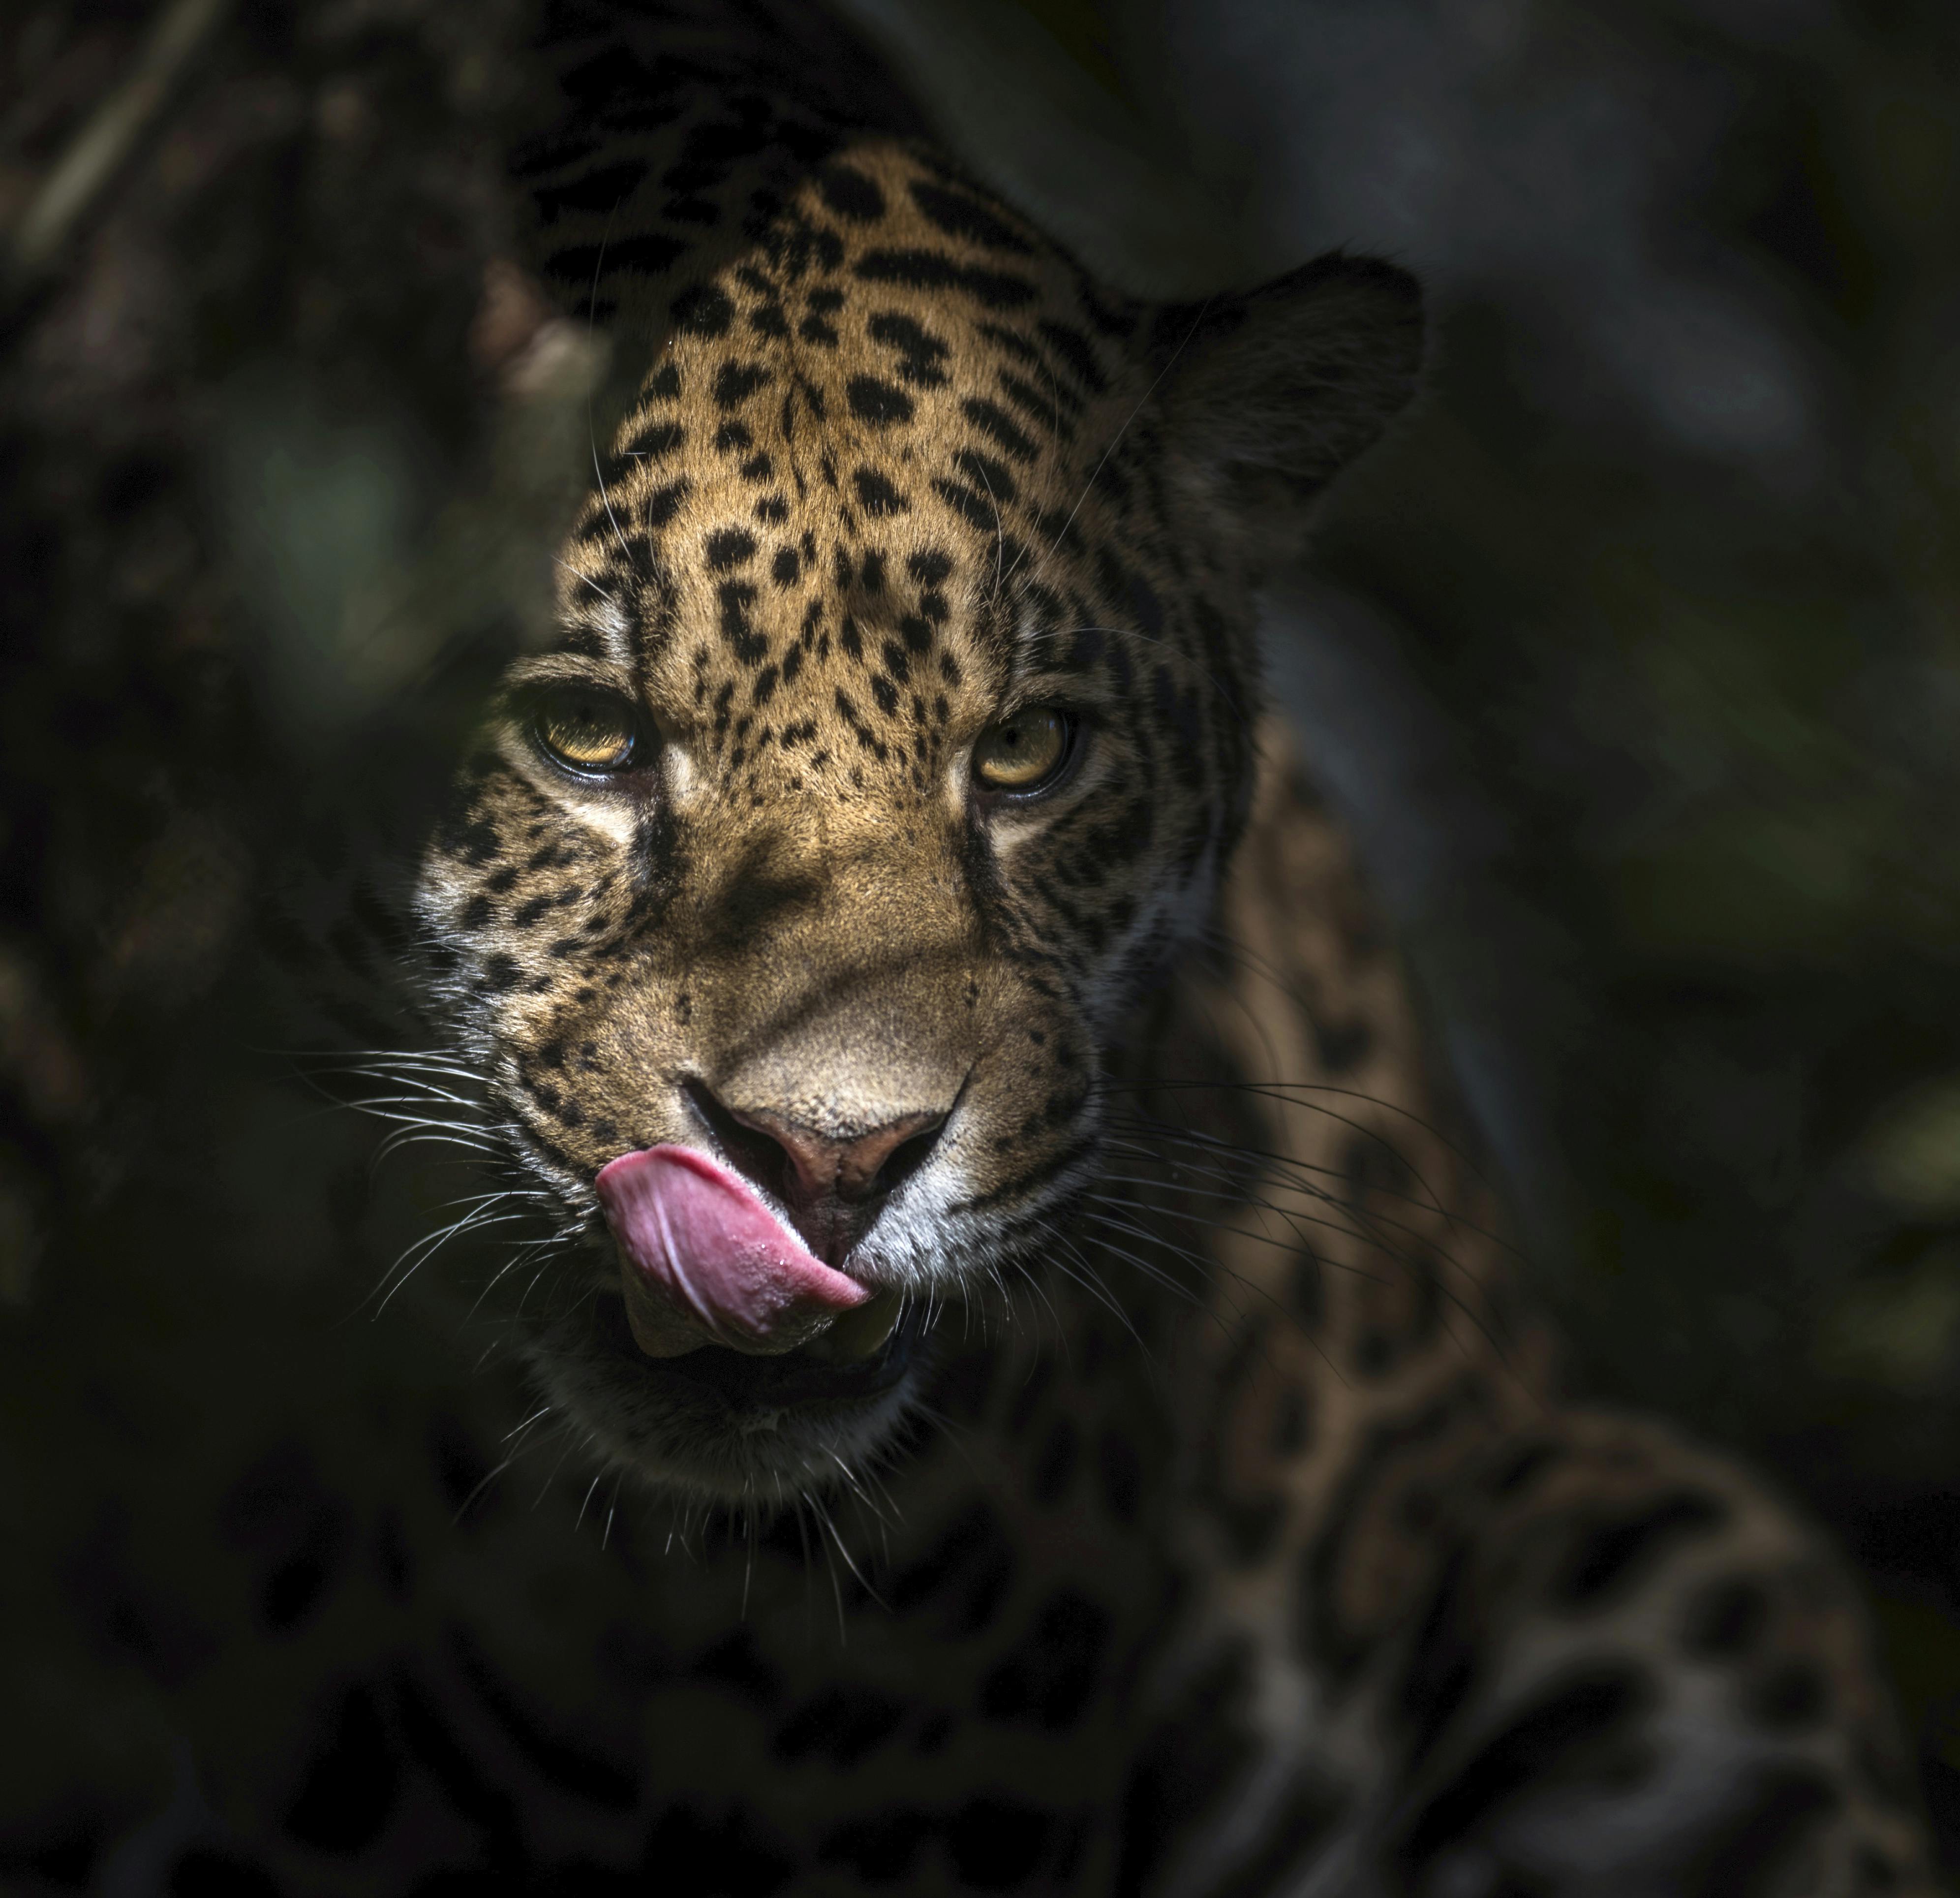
0,0,1936,1898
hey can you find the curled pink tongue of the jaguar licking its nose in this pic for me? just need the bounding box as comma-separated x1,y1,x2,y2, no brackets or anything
596,1147,870,1357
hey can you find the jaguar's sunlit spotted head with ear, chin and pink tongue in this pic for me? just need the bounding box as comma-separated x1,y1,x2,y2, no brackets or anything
405,141,1419,1504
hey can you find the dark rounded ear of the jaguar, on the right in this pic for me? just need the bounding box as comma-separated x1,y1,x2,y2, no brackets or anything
1151,251,1423,576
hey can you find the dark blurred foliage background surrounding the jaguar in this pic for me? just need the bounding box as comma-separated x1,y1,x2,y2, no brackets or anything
11,0,1960,1874
